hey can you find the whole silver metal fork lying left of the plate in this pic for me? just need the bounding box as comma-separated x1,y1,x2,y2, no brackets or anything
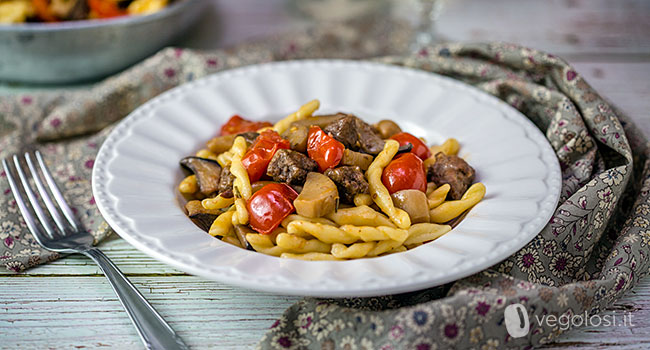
2,151,188,349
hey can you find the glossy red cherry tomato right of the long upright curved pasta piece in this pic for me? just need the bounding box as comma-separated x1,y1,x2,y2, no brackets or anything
381,153,427,194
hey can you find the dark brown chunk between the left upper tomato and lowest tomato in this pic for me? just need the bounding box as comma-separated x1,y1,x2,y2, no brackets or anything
266,149,318,185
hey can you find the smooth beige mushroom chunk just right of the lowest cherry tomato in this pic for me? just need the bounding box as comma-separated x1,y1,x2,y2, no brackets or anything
293,172,339,218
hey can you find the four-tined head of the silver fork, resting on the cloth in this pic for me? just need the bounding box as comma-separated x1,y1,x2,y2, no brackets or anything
2,151,81,245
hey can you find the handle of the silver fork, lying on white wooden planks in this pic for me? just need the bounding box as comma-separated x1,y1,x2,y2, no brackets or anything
82,248,189,350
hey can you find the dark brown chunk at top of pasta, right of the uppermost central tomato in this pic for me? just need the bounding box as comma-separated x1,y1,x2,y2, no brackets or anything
323,115,384,155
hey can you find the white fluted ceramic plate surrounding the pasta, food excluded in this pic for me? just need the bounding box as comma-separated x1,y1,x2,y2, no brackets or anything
92,60,561,297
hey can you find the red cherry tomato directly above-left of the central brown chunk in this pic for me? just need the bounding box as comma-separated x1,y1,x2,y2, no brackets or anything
241,129,291,182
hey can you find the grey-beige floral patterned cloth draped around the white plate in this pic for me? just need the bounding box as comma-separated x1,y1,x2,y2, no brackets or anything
0,23,650,350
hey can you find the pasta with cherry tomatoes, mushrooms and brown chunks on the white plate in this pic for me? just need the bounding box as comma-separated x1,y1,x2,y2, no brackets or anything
178,100,486,260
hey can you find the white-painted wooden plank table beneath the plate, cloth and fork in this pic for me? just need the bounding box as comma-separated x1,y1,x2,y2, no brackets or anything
0,0,650,349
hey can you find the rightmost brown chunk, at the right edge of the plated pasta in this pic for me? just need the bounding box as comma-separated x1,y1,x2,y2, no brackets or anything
427,152,475,200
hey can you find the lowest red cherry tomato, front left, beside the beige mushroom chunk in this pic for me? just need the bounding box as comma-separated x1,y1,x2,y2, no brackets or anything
246,183,298,235
